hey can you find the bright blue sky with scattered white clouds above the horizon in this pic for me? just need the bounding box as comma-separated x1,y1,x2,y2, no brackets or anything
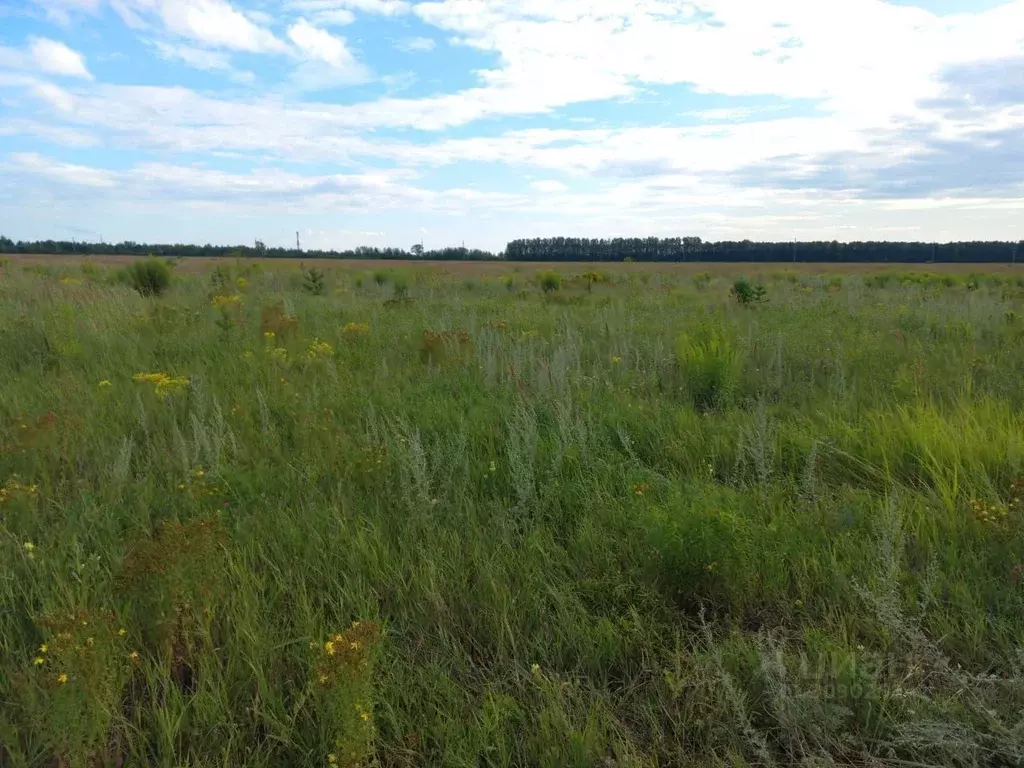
0,0,1024,251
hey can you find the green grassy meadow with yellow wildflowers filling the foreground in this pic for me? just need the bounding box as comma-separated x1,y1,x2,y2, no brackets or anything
0,260,1024,768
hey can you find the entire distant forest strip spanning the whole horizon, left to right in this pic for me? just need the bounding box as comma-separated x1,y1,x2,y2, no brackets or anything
0,237,1024,264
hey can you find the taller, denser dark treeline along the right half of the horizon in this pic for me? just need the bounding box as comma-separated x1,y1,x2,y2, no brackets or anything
505,238,1024,263
